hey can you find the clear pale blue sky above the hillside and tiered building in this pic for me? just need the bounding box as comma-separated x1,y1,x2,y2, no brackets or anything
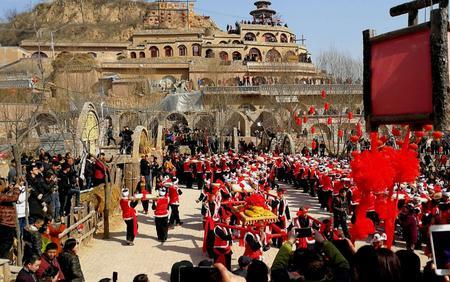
0,0,436,58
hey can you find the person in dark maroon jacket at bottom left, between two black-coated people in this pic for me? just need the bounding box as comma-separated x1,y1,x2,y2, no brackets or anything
36,242,64,282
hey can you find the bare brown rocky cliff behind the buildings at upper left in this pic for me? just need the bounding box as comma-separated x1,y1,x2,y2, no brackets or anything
0,0,215,46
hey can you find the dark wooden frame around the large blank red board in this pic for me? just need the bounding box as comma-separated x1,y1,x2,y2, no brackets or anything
363,0,450,132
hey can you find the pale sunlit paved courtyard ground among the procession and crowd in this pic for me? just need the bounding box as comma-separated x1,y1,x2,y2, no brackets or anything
79,185,426,282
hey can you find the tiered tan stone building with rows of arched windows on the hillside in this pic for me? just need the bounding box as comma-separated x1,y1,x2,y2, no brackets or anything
0,0,362,154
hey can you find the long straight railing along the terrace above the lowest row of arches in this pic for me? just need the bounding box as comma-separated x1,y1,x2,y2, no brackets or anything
200,84,363,96
